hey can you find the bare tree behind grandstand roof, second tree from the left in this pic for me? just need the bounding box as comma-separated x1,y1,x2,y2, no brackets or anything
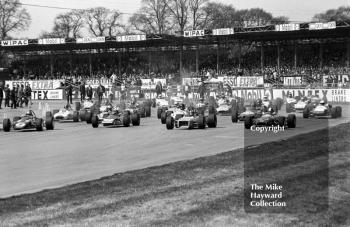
52,10,84,38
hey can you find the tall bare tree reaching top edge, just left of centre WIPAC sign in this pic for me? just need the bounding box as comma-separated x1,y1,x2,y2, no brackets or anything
129,0,170,34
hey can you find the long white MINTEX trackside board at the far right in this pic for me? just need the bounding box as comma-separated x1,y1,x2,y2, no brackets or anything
273,88,350,103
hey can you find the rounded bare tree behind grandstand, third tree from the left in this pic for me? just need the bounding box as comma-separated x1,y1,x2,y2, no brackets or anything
85,7,124,36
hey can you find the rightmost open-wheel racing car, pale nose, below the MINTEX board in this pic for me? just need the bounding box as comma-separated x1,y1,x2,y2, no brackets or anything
303,100,342,118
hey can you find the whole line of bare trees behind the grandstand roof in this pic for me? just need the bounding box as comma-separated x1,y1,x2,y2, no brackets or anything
0,0,350,39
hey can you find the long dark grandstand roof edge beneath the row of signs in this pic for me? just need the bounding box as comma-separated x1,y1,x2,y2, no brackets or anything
0,23,350,52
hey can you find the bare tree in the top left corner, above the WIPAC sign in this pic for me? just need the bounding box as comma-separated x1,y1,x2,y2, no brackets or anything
0,0,31,39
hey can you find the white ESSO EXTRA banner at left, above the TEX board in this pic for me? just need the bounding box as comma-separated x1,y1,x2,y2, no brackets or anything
5,80,61,90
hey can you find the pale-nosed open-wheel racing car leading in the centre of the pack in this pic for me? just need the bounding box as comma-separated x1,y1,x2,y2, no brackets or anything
166,104,217,130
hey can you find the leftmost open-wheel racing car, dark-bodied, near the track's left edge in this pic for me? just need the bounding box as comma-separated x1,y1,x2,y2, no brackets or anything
3,110,54,132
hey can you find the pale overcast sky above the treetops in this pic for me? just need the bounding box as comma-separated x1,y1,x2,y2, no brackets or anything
17,0,350,38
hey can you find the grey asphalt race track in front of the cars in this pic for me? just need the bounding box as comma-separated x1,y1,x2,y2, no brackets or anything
0,106,350,198
